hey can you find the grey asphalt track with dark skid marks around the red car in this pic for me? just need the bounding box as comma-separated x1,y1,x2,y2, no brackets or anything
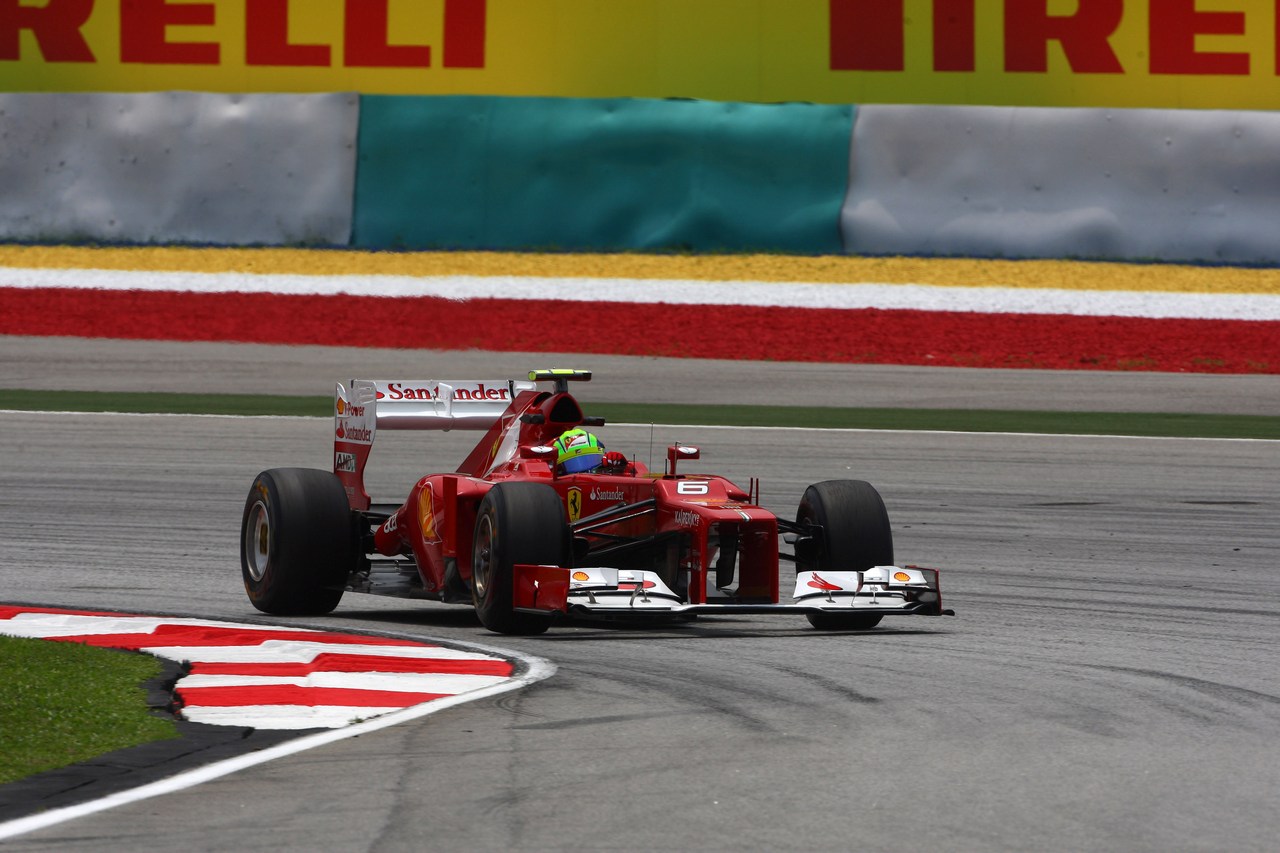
0,342,1280,850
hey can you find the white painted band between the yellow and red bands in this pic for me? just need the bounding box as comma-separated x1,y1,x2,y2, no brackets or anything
0,266,1280,320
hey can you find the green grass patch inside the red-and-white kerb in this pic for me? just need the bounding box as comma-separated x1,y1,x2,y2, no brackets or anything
0,637,178,784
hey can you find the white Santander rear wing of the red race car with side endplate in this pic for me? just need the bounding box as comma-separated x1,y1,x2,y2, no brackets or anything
333,379,536,510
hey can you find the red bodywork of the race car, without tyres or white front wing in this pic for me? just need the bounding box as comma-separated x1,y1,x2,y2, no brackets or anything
334,383,780,611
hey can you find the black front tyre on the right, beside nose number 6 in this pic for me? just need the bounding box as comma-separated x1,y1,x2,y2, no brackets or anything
796,480,893,630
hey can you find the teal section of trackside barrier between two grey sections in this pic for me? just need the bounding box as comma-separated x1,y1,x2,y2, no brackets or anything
352,96,854,254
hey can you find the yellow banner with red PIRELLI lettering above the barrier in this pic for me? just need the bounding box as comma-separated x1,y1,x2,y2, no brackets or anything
0,0,1280,110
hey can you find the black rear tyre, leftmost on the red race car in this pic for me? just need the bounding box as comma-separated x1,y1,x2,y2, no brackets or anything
241,467,358,616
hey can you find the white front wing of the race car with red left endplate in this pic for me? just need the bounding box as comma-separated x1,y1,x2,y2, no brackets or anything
513,564,955,616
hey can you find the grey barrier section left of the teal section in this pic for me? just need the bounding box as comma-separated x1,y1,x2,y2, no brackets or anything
0,92,360,245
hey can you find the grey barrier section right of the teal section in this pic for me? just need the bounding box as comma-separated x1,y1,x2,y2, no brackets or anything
841,105,1280,263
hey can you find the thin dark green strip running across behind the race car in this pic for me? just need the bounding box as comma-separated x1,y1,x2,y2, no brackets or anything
0,389,1280,439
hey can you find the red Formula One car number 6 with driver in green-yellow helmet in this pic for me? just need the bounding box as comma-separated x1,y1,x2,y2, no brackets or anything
241,370,951,634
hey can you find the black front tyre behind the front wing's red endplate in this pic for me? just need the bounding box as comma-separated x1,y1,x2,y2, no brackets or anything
471,483,571,634
